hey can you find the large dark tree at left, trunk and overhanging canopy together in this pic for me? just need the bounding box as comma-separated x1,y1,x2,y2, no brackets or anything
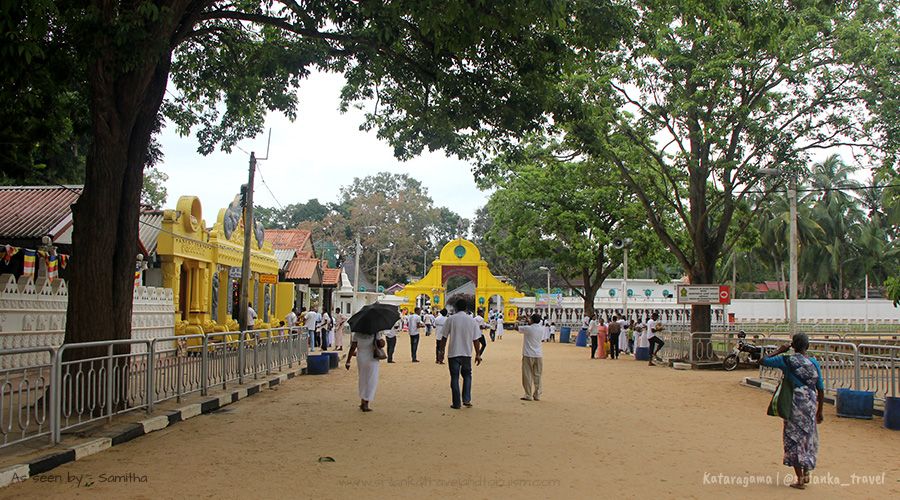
0,0,566,342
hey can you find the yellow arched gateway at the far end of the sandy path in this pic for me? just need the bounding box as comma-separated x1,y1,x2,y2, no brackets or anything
396,238,525,323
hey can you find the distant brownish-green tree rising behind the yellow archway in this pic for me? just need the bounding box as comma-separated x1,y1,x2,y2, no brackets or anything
313,172,469,288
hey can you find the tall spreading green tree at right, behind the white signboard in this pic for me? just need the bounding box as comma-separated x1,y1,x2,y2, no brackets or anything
474,0,898,331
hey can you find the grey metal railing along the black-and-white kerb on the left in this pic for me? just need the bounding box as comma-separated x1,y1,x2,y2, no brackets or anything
0,328,308,448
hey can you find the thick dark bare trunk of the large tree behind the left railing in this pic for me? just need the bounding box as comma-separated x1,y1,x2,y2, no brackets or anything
66,39,170,359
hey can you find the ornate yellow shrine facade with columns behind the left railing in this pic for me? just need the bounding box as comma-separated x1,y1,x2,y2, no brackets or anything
157,196,278,334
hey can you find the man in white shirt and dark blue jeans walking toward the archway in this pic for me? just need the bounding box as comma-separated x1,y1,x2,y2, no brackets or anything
443,299,481,410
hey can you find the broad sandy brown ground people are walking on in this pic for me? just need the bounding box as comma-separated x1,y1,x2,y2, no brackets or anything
0,332,900,499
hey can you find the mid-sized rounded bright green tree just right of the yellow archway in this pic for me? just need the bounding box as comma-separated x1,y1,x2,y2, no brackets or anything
487,139,663,314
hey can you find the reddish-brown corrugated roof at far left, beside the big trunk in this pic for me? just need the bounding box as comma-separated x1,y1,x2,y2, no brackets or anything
0,186,82,238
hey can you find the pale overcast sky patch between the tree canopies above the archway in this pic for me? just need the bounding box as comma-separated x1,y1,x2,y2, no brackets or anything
160,68,489,226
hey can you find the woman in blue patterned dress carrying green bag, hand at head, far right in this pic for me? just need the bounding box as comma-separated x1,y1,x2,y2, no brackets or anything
762,333,825,490
